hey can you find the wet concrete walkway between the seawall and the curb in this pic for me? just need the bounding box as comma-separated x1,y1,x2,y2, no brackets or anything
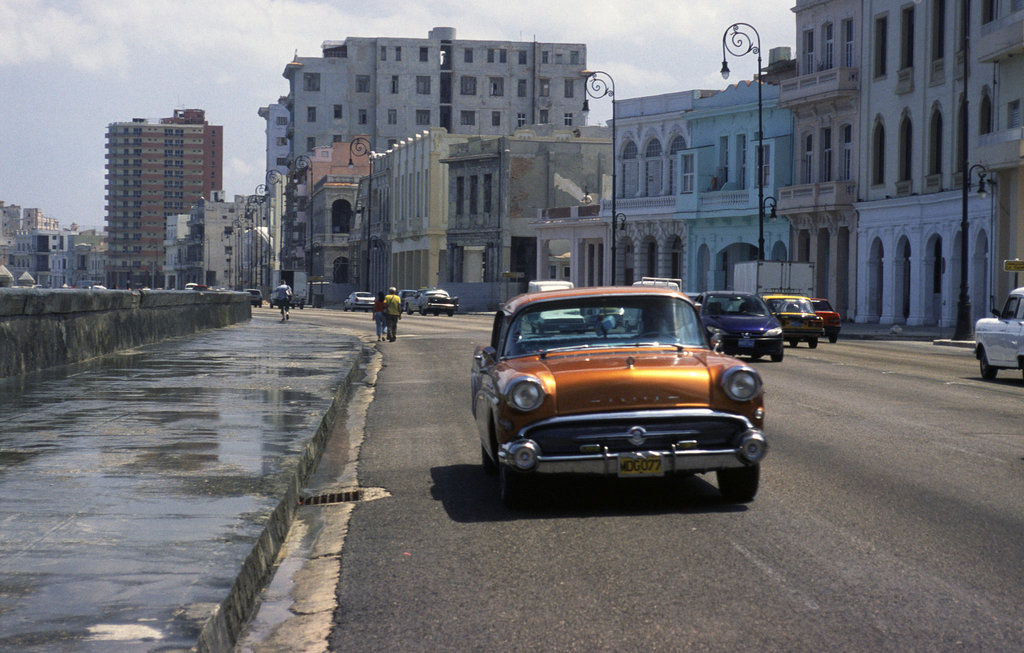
0,311,361,652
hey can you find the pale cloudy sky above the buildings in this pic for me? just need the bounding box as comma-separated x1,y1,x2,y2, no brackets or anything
0,0,796,234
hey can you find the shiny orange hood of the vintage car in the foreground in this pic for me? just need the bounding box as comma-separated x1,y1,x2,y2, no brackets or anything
520,348,711,415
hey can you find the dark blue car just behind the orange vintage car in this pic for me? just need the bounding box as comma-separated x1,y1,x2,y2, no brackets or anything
695,291,784,362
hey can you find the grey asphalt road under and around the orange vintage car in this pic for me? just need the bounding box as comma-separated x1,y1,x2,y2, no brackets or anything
264,314,1024,651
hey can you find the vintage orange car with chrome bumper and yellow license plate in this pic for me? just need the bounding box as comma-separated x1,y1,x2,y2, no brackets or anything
471,287,767,508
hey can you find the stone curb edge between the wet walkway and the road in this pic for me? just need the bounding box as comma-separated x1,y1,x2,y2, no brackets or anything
194,339,365,653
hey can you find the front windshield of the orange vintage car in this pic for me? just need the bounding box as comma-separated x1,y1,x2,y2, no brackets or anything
505,296,707,356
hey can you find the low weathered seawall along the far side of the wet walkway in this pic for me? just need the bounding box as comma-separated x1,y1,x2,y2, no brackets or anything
0,288,252,378
